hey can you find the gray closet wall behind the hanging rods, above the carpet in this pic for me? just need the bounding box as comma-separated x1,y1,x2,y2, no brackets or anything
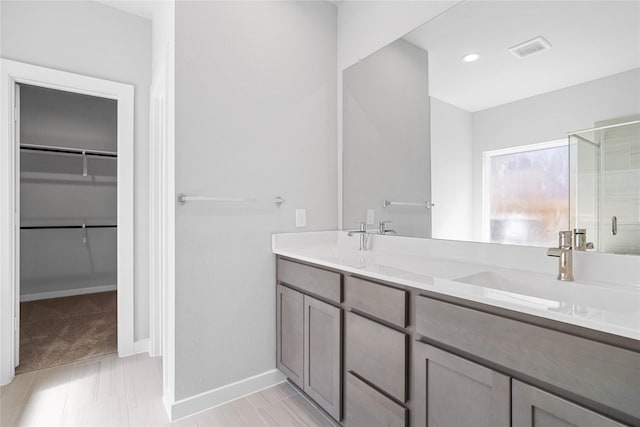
20,85,117,295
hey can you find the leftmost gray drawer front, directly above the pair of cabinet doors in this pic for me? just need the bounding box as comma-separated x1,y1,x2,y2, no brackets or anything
277,258,342,303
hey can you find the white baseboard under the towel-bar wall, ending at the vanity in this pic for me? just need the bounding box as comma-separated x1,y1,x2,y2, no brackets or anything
165,369,285,422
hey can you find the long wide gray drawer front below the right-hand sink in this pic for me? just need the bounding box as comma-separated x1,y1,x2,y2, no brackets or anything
416,297,640,419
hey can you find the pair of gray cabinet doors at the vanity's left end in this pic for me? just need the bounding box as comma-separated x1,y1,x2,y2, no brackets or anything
276,285,342,420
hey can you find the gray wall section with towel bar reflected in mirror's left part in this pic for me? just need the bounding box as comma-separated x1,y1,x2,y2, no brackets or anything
342,40,431,237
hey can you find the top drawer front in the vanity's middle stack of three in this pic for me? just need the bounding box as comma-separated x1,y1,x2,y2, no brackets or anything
345,277,408,328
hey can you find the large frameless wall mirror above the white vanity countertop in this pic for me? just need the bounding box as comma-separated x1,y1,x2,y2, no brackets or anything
342,0,640,254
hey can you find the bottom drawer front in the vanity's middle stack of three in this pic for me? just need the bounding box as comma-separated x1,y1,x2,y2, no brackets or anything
344,372,408,427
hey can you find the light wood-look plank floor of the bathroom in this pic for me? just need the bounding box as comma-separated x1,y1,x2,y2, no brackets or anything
0,354,334,427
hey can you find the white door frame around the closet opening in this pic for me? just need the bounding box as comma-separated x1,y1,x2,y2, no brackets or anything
0,58,134,384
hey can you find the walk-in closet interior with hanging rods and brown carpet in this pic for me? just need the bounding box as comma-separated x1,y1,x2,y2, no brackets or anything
16,84,118,373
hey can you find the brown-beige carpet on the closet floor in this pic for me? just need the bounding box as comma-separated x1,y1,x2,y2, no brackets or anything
16,291,118,374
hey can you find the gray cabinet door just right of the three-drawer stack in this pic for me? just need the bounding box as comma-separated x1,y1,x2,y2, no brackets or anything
414,342,510,427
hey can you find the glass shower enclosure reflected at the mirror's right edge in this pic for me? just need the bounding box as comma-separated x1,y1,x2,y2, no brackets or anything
569,116,640,255
